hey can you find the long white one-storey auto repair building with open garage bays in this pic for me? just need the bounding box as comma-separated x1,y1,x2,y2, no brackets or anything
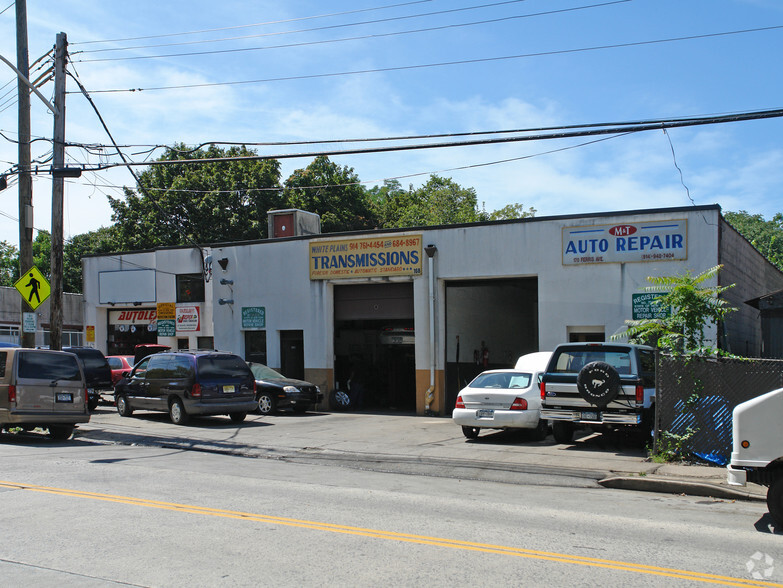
83,205,783,415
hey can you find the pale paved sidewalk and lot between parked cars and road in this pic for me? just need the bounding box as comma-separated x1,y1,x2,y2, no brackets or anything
81,406,766,500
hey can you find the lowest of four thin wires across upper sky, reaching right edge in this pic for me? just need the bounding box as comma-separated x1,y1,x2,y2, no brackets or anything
78,25,783,94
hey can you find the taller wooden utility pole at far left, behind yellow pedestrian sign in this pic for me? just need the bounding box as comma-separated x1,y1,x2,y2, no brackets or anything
16,0,35,347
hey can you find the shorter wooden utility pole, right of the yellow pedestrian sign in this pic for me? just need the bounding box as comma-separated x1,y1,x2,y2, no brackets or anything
49,33,68,350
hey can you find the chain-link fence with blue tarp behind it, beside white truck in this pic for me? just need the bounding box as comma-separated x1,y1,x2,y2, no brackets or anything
655,354,783,465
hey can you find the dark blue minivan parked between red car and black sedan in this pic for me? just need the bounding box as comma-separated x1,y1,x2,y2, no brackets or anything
114,351,256,425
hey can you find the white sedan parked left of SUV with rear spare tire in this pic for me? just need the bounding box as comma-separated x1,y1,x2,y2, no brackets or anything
451,351,552,440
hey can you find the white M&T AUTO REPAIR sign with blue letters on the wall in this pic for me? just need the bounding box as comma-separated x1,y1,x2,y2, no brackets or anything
563,219,688,265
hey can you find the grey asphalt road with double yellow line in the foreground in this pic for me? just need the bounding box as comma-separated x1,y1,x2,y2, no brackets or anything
0,411,783,587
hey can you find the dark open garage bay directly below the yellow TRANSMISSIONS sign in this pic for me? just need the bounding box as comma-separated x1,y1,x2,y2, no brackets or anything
334,282,416,412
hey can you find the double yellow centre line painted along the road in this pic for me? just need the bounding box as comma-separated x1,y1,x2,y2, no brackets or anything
0,481,783,588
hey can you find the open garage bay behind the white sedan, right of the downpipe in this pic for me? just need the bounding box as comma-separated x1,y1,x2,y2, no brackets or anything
446,278,539,414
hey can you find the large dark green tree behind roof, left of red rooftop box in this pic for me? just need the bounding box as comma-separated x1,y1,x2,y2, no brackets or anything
109,144,283,250
